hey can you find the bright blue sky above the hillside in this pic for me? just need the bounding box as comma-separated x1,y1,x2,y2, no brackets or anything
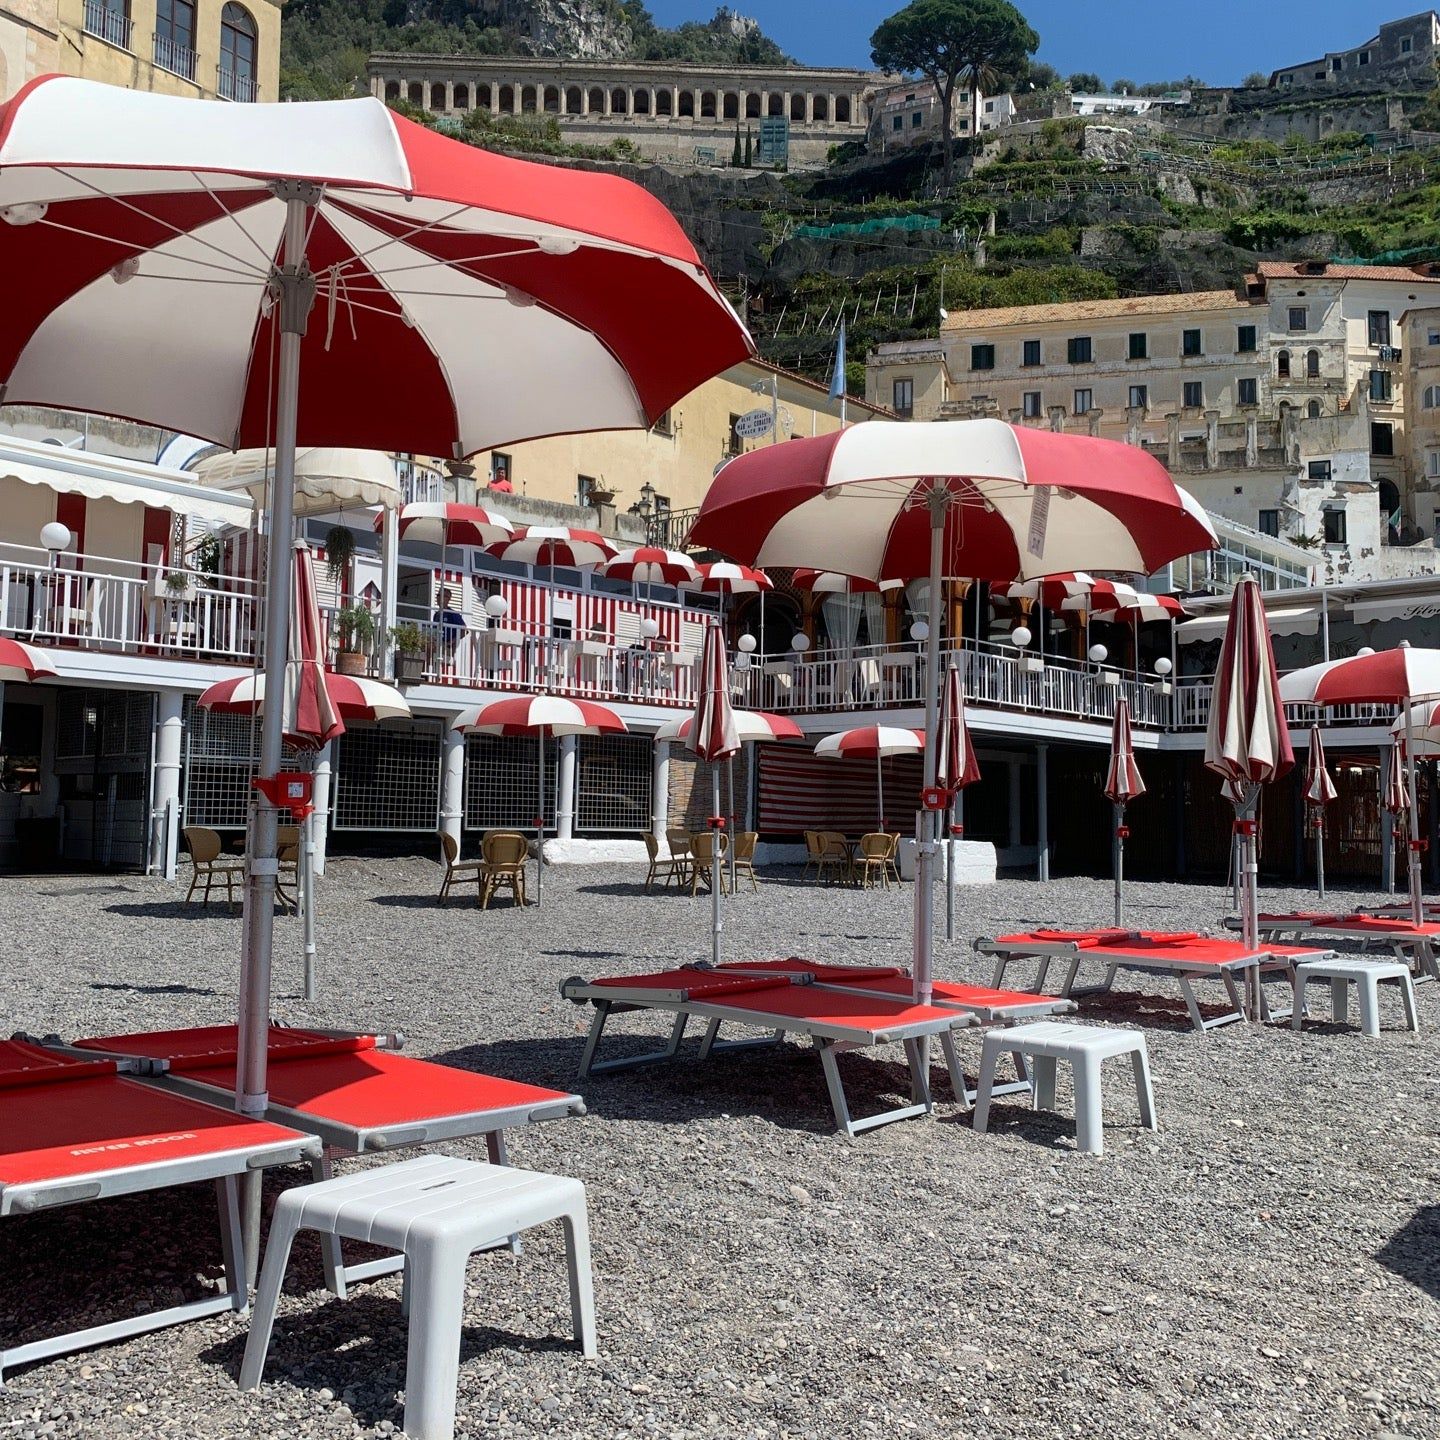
645,0,1382,85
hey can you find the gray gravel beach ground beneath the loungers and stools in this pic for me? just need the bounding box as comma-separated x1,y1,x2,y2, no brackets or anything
0,860,1440,1440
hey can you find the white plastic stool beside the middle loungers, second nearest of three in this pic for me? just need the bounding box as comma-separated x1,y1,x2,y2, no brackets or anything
975,1020,1158,1155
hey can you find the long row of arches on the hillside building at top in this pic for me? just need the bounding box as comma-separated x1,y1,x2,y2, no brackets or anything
384,79,855,125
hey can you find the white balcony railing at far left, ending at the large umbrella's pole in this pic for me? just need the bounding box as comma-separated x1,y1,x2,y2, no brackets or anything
0,547,259,661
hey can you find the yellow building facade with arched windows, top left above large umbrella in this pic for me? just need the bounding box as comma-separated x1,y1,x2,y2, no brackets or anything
49,0,281,102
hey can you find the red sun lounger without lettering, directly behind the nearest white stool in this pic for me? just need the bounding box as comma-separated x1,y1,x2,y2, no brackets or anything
66,1025,585,1296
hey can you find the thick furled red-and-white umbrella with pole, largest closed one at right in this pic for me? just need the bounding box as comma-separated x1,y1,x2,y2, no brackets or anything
1205,575,1295,949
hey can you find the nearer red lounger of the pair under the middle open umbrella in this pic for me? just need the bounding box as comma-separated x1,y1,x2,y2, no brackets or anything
560,969,972,1136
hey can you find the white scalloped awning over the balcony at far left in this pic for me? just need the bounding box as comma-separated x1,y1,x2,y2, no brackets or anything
0,435,253,530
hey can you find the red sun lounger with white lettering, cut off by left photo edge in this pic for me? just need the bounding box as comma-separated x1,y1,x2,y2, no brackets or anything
0,1040,320,1384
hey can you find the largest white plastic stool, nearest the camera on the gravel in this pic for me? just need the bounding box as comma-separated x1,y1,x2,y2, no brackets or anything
240,1155,595,1440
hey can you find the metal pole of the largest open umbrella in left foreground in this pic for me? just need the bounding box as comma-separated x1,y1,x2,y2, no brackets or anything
235,181,318,1284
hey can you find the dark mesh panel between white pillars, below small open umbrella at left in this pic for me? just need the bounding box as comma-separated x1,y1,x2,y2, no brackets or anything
333,720,444,832
